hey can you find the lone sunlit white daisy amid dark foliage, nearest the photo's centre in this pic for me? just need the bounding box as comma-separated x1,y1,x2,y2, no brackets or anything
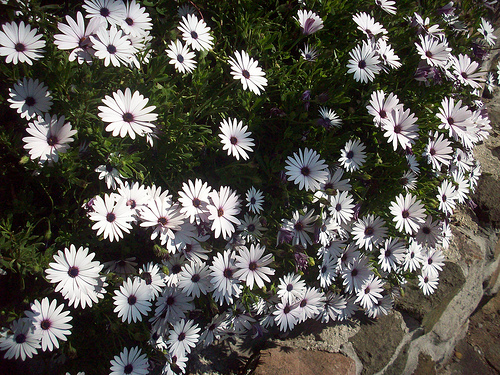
219,118,255,160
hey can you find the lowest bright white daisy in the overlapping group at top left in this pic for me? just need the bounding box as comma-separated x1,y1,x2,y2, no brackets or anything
90,25,135,67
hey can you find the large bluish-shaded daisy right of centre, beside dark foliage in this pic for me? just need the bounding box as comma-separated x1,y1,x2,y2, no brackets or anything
285,147,328,191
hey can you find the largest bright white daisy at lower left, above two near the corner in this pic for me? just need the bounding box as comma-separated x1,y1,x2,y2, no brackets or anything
45,244,104,307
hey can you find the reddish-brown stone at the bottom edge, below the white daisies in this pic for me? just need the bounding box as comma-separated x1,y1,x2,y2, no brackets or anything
255,347,356,375
